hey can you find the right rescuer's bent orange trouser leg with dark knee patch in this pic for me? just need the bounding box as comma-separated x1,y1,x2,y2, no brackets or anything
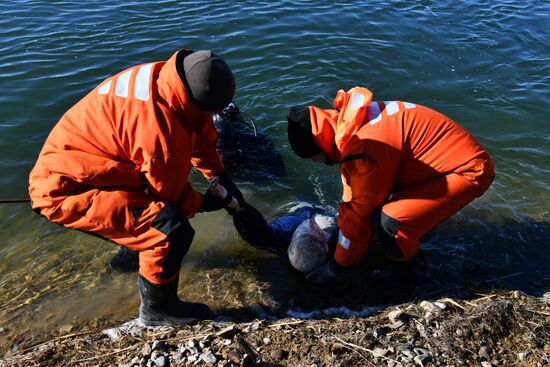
381,173,490,260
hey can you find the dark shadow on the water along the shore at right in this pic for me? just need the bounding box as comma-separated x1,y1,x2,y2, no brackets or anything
204,213,550,321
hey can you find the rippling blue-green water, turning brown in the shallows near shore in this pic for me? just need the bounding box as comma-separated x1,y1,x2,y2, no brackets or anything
0,0,550,349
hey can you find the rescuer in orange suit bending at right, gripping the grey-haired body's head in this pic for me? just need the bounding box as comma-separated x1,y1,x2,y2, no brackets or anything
288,87,494,284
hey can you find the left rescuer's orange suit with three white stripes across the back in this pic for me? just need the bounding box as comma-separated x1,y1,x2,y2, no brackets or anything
29,50,224,283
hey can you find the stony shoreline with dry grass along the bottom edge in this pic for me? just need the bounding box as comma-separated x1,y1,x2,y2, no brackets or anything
0,291,550,367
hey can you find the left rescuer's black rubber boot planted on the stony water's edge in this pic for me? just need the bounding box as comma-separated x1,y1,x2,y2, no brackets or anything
138,275,214,326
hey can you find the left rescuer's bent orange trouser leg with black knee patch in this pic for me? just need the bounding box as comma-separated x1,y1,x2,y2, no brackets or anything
41,190,195,284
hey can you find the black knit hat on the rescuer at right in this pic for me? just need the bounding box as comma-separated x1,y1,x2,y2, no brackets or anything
287,106,322,159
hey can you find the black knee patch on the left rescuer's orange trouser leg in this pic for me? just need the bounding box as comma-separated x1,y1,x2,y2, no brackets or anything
151,203,195,279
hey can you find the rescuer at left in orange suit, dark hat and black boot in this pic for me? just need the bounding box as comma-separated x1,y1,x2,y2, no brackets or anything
29,49,244,325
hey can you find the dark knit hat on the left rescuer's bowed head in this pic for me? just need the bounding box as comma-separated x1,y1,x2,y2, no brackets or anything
183,51,235,111
